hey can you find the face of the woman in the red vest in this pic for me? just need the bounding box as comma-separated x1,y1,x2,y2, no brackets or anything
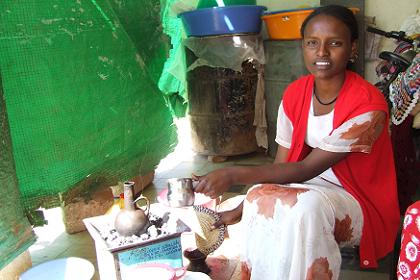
302,15,356,80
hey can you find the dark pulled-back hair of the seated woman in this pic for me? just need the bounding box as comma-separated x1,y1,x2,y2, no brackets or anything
300,5,359,42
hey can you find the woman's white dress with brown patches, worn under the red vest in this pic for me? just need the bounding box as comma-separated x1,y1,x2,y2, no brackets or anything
241,97,379,280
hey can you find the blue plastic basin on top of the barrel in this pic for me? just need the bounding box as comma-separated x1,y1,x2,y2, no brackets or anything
178,5,267,37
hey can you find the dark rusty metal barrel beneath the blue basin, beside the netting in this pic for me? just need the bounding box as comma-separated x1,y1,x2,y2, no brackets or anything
186,48,258,156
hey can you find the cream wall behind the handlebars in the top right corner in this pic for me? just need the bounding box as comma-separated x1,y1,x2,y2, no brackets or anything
365,0,420,83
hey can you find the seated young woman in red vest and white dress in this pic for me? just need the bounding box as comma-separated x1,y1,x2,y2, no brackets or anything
196,5,400,280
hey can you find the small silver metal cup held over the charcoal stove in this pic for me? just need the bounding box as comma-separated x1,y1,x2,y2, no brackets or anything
167,178,195,207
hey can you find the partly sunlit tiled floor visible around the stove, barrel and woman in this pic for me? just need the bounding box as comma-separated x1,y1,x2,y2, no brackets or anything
30,120,389,280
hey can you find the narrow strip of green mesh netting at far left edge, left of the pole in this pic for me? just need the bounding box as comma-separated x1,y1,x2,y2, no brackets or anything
0,75,35,270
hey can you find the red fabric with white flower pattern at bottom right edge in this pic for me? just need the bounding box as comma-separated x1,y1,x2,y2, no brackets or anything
397,200,420,280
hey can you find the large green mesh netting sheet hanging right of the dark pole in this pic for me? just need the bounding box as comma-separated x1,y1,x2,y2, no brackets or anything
0,0,176,219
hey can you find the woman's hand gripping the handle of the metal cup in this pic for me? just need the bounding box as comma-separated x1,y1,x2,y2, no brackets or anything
192,168,232,199
